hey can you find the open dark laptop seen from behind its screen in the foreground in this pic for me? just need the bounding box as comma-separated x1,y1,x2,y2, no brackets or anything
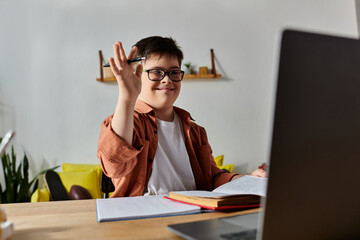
168,30,360,240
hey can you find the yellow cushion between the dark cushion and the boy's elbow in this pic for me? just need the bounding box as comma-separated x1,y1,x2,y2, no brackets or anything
58,170,101,198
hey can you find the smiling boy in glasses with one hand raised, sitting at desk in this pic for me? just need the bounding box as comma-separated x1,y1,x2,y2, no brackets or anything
98,36,266,197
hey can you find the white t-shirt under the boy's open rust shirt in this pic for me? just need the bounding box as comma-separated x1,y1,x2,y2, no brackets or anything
144,113,196,195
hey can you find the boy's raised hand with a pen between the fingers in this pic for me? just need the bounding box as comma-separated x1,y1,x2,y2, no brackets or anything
109,42,143,102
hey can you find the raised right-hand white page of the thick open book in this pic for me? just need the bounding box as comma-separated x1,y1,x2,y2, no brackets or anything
213,175,267,196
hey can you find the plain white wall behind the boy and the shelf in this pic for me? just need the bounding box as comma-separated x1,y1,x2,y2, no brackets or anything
0,0,358,176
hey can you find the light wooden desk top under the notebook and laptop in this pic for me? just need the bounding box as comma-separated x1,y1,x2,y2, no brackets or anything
1,199,258,240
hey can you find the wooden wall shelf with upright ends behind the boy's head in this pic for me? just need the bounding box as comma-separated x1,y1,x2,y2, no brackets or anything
96,49,222,82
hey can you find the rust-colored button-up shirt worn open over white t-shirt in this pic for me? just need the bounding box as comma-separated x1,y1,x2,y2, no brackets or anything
97,100,236,197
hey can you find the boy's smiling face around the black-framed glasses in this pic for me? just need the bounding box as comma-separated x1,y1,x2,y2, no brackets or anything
139,54,181,110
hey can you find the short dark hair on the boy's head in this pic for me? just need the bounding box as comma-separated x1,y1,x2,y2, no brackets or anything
134,36,183,65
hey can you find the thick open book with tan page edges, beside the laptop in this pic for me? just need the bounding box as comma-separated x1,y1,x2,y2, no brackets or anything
168,175,267,210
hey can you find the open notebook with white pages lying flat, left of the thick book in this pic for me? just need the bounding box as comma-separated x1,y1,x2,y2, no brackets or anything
96,195,201,222
